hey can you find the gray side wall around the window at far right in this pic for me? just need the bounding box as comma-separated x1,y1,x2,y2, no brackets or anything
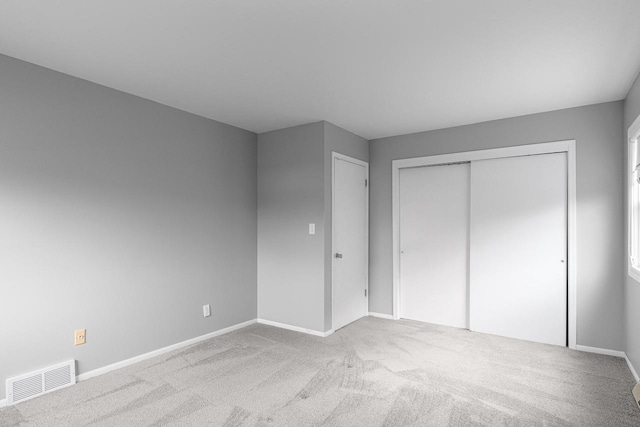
621,72,640,373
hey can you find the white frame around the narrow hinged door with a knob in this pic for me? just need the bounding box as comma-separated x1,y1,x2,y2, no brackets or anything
331,151,369,331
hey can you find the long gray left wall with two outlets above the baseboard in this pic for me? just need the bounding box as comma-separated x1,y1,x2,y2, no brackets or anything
0,55,257,399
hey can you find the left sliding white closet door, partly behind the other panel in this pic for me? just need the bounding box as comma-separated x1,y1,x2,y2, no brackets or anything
400,163,469,328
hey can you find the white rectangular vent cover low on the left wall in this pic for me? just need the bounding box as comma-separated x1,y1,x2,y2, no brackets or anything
7,360,76,405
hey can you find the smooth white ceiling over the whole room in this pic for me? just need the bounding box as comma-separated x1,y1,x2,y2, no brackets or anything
0,0,640,139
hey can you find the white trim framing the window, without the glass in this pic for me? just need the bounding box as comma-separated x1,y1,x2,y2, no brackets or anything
625,115,640,282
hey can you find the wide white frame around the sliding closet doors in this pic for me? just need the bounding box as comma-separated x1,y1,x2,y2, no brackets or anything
391,140,577,349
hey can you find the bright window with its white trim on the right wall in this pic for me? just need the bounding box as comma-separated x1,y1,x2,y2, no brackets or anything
626,115,640,282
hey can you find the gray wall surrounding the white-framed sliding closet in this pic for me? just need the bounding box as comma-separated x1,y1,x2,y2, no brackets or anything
369,101,624,350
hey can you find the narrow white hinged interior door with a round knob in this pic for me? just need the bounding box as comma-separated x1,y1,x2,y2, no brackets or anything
332,155,369,330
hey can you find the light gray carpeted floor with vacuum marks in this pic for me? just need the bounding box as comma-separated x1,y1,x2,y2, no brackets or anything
0,317,640,427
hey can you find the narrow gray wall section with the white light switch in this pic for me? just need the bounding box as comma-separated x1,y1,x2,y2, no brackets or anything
258,122,324,332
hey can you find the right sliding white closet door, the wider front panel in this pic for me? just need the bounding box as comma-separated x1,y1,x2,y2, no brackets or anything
469,153,567,346
